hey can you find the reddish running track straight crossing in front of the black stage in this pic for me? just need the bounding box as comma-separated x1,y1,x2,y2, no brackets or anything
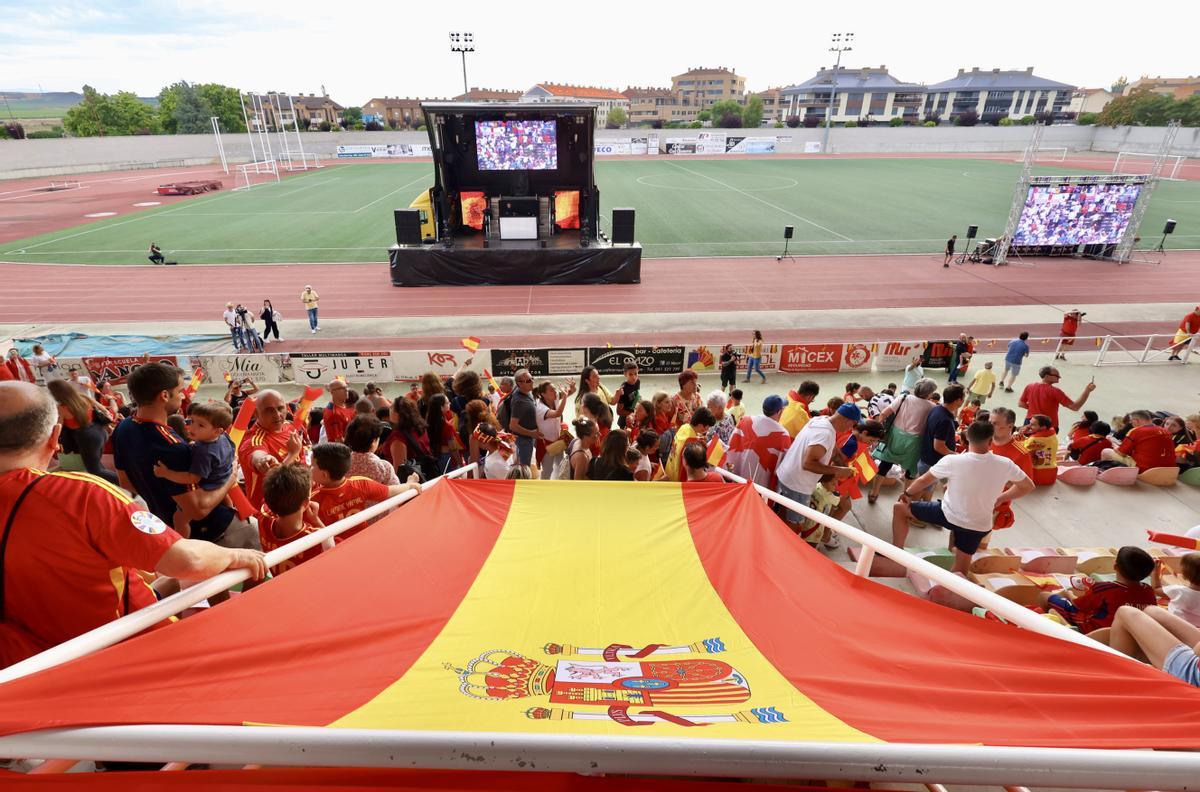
0,251,1200,331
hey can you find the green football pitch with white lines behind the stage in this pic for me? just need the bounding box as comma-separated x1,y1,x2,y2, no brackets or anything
0,157,1200,264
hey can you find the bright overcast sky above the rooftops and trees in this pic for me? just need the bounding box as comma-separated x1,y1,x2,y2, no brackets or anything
0,0,1200,106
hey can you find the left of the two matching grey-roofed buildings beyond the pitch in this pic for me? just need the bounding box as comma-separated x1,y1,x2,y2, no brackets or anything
782,66,925,124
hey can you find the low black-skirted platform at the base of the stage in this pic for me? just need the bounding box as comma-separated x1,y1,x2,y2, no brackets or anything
388,233,642,286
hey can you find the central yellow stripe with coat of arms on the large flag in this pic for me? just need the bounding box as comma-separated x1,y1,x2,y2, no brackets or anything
331,481,878,743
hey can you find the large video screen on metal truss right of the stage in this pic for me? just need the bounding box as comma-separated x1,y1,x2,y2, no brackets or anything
1013,184,1141,245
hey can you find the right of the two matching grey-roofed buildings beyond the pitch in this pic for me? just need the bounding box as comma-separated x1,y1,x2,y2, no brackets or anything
923,66,1075,122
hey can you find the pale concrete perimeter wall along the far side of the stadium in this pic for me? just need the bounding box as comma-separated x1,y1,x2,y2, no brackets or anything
0,125,1200,179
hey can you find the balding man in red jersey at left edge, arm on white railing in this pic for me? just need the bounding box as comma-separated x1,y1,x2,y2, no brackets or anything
0,382,266,667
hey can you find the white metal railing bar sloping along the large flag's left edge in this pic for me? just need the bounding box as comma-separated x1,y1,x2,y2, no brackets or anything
0,463,475,684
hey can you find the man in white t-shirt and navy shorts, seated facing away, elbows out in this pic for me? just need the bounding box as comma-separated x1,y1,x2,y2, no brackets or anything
892,422,1033,575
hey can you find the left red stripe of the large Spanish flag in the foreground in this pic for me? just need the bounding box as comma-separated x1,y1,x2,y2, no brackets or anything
0,480,514,733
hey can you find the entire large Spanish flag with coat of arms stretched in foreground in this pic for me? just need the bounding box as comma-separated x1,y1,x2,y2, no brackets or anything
0,481,1200,749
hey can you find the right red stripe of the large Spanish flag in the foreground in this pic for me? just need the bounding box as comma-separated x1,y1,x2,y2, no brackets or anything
683,485,1200,749
